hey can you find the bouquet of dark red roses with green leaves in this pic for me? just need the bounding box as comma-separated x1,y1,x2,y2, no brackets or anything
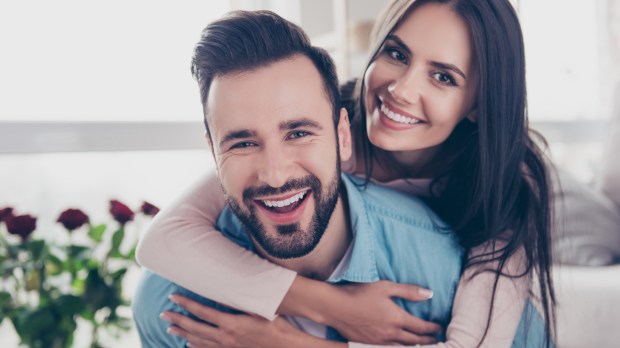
0,200,159,348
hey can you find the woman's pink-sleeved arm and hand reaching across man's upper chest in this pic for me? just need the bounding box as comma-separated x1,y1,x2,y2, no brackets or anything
137,174,440,343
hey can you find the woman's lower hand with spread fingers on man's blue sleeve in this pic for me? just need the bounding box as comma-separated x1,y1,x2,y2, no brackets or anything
161,295,346,348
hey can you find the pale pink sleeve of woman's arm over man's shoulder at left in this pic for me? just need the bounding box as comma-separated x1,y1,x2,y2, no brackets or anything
136,170,296,319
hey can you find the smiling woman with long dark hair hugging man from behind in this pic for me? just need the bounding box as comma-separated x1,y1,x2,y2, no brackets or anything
138,0,554,347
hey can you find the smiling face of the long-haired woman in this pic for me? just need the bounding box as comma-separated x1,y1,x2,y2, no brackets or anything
364,3,478,158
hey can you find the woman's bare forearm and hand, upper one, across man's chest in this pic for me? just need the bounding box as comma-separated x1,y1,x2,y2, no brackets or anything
279,276,441,345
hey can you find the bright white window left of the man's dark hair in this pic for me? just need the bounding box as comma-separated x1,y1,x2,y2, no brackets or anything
0,0,230,122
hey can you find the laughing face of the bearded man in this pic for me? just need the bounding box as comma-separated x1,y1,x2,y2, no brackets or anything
206,56,350,259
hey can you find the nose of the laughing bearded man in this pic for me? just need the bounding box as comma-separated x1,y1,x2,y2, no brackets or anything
258,145,295,188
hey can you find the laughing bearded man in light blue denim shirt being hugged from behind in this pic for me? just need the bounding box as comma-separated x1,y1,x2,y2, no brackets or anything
133,12,540,347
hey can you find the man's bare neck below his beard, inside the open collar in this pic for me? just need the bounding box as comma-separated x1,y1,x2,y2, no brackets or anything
255,186,353,280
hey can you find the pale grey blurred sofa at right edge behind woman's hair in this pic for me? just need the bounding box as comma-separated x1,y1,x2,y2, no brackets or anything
554,85,620,348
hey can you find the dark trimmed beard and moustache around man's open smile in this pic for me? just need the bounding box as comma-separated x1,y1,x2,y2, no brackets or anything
224,167,340,259
